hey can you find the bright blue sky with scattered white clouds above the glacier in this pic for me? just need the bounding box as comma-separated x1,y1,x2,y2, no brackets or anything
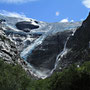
0,0,90,22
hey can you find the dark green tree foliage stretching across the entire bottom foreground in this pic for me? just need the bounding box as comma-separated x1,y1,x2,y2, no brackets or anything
0,57,90,90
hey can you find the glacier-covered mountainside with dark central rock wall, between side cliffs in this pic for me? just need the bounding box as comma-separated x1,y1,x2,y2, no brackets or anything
0,15,81,78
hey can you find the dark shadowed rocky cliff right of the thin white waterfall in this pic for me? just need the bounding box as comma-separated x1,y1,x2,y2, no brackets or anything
59,14,90,68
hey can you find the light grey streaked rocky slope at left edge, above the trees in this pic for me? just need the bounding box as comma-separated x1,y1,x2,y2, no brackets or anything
0,25,19,63
